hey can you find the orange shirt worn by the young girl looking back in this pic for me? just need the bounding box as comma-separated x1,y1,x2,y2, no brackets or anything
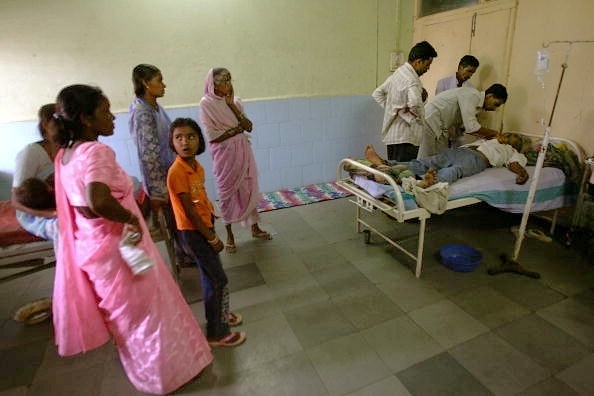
167,156,214,230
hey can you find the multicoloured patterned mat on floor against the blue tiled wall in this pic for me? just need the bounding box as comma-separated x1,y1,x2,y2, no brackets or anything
258,182,351,212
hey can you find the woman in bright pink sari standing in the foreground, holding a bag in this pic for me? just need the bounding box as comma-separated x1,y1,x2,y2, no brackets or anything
53,85,212,394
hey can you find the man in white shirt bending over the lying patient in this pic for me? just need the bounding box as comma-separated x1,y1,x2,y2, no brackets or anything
417,84,507,158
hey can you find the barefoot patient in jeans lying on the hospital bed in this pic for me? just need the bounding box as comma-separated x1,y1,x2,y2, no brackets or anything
365,133,528,188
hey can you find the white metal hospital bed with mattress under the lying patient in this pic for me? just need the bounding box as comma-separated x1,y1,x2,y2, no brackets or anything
337,132,584,278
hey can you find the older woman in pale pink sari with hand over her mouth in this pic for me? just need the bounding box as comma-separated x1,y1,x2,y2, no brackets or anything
200,67,272,253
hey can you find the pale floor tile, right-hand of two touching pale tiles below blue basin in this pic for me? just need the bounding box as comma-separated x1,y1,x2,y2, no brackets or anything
409,300,489,349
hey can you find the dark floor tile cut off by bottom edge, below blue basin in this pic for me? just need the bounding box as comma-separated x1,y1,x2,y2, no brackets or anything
396,352,493,396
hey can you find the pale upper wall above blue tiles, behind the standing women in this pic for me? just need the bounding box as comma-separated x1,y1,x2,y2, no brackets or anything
0,0,386,122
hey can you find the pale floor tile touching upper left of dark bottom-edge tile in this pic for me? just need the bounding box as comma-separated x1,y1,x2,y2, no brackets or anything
361,316,443,373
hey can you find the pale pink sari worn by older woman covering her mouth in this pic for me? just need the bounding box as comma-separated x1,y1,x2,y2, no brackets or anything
200,69,261,226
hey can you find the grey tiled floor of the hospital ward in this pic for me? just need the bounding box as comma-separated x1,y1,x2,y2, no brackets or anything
0,199,594,396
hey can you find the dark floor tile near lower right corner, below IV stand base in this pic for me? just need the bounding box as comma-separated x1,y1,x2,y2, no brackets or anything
495,314,590,373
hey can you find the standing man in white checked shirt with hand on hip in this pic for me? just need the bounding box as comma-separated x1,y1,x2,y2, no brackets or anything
371,41,437,161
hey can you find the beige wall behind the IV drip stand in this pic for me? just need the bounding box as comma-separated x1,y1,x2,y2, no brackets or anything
505,0,594,155
